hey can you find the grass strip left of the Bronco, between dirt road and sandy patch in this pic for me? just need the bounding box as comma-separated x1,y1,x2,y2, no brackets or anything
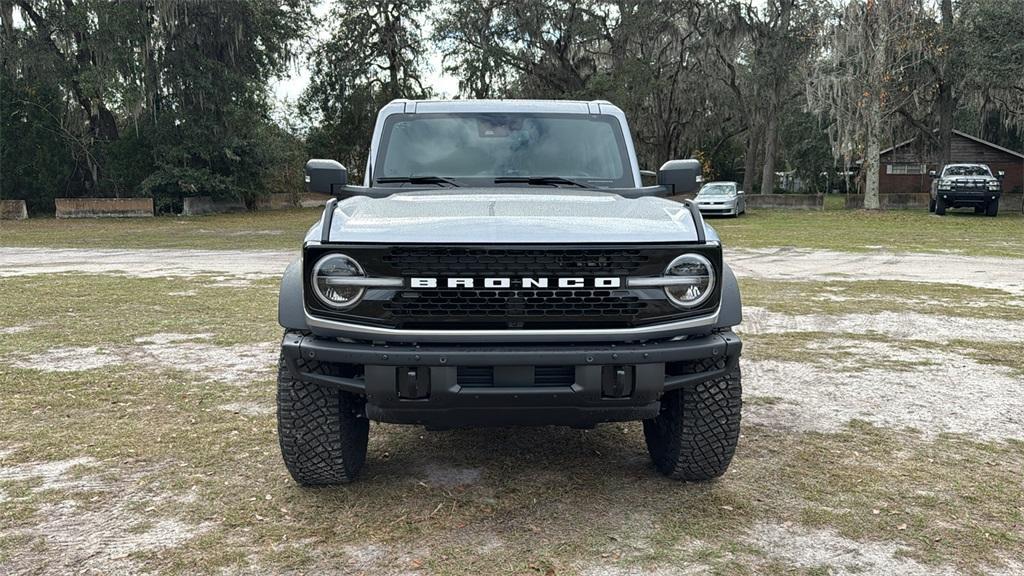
0,274,281,355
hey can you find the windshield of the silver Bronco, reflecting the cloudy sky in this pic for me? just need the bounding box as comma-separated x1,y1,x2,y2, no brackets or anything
374,113,635,188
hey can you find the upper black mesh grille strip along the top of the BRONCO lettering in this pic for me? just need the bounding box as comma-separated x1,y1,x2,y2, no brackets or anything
383,247,650,277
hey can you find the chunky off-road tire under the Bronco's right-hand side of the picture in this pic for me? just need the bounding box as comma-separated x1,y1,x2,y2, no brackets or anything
643,360,742,481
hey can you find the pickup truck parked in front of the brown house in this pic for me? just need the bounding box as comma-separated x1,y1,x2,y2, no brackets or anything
928,164,1006,216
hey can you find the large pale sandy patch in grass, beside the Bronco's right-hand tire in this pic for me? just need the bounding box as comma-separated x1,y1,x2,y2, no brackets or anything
743,338,1024,440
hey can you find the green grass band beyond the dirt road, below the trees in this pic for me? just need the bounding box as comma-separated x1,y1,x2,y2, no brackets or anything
0,201,1024,258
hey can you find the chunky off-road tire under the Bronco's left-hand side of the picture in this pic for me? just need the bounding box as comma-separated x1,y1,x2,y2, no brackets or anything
278,332,370,486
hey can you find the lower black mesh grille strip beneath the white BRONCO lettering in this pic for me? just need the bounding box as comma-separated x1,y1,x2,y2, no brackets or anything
384,289,647,319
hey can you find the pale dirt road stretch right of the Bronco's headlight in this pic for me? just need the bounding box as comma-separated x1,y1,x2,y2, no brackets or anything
725,248,1024,294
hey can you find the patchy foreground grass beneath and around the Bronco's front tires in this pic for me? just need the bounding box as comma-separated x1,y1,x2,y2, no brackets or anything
0,360,1024,574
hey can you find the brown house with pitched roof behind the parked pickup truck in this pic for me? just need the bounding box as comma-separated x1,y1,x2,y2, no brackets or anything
879,130,1024,194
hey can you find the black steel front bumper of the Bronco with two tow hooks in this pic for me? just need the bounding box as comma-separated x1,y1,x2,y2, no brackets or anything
282,331,742,427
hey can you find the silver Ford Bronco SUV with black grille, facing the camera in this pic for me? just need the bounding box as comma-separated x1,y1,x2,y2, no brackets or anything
278,100,740,485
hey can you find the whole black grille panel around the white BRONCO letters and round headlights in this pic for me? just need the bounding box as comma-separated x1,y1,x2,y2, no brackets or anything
304,244,721,330
